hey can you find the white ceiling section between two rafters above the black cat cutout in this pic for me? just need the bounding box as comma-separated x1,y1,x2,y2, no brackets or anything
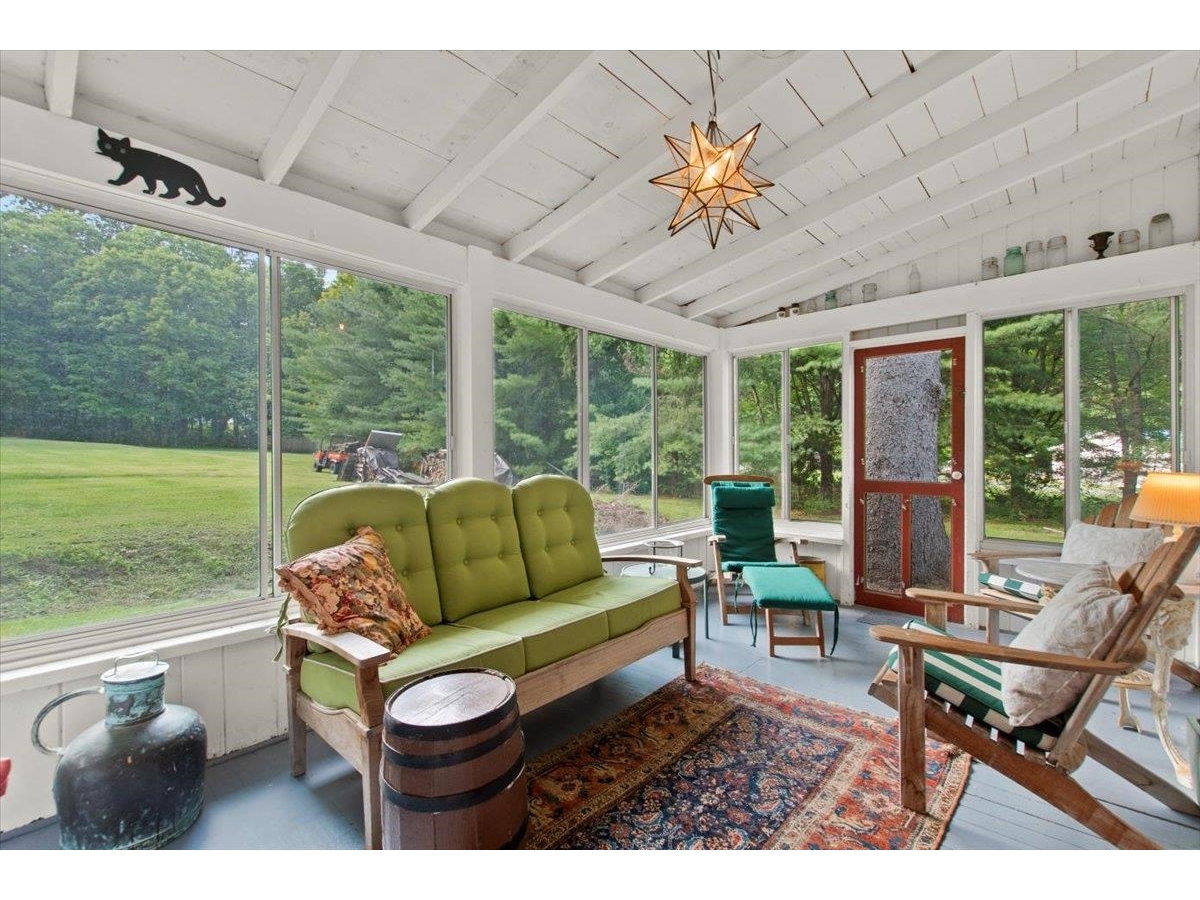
77,50,292,158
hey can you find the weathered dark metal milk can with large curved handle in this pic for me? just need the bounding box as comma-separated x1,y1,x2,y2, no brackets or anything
32,653,208,850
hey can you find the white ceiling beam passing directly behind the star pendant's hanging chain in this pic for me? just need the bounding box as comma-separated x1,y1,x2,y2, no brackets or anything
504,50,809,262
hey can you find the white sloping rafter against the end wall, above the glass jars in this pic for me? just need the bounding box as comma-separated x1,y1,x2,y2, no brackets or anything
716,134,1200,328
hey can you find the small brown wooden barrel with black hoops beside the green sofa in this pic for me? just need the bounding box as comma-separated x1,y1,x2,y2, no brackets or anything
380,668,529,850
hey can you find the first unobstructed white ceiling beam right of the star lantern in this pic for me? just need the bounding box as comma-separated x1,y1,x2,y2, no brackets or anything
637,50,1164,302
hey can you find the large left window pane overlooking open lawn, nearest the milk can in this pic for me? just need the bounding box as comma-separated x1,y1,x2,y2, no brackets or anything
0,196,264,638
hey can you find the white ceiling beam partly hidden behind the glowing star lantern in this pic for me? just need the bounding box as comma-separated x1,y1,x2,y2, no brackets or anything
578,50,996,286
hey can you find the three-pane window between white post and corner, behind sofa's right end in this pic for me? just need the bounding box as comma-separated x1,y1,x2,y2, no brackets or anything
493,310,704,534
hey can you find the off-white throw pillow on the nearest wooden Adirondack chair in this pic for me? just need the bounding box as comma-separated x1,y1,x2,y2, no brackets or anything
1000,566,1133,725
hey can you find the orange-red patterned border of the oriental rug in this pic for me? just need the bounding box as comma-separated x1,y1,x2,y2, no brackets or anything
522,664,971,850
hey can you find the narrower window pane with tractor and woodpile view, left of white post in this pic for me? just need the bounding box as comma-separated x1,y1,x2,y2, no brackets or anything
280,260,446,520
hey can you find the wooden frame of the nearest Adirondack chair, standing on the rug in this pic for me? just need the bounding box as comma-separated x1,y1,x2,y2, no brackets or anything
869,528,1200,850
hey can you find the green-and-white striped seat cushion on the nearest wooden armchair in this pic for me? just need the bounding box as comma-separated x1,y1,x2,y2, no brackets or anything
888,619,1063,750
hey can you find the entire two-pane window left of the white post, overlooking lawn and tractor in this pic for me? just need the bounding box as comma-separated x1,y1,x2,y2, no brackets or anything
0,196,448,640
